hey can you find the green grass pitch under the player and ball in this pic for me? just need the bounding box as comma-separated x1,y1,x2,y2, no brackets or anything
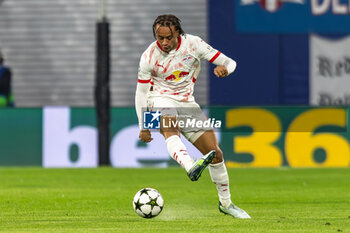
0,167,350,233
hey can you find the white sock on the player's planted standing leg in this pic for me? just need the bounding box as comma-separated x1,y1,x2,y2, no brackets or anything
209,161,232,207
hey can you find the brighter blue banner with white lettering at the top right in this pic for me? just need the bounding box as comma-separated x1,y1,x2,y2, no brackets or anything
235,0,350,33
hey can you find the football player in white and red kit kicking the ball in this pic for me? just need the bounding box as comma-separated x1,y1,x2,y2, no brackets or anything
135,14,250,218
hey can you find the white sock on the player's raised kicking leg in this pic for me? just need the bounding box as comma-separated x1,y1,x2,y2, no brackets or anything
165,135,193,171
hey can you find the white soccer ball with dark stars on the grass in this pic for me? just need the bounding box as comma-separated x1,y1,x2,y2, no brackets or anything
132,188,164,218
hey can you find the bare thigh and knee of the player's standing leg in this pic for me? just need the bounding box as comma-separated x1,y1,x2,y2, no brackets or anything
193,130,224,163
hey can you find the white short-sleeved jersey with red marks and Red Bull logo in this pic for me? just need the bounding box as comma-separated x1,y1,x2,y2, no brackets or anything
138,34,220,102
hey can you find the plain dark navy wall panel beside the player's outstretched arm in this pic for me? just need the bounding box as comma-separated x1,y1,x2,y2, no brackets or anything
208,0,309,106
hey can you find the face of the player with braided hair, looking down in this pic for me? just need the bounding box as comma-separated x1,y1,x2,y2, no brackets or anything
155,25,179,52
